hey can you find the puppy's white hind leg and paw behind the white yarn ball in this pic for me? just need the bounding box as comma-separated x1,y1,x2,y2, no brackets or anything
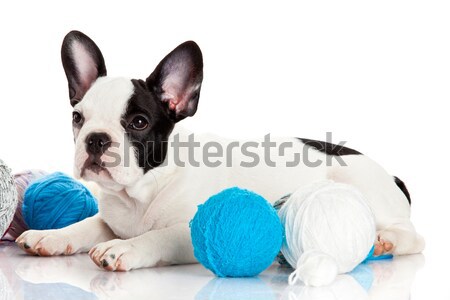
328,155,425,255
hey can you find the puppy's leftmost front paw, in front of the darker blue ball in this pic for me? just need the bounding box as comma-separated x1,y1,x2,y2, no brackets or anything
16,230,73,256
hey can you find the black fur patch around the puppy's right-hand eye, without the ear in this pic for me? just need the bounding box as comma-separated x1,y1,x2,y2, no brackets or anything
121,79,175,173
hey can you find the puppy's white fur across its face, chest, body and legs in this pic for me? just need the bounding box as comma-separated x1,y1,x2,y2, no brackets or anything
17,78,424,270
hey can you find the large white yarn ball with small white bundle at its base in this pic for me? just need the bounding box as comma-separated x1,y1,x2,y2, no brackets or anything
279,180,376,286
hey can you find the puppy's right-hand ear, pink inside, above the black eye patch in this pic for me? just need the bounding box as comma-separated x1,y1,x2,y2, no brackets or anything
146,41,203,122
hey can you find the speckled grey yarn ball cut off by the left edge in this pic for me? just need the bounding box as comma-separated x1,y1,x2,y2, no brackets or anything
0,159,17,238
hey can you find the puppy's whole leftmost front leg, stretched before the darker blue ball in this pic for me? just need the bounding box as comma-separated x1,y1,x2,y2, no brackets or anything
16,214,116,256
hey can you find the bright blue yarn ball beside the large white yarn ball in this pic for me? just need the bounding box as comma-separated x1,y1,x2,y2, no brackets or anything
190,187,283,277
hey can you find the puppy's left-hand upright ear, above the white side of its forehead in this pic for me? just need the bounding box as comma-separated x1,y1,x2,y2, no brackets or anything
61,31,106,106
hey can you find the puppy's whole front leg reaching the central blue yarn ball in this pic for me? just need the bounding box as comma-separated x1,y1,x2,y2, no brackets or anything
89,223,197,271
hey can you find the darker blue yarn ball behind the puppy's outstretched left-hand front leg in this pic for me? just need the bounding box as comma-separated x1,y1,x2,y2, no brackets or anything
22,172,98,230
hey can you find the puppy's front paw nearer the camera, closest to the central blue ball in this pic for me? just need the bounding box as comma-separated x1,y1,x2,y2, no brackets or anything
89,239,143,271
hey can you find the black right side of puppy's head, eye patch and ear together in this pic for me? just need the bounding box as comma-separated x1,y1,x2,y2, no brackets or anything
121,41,203,173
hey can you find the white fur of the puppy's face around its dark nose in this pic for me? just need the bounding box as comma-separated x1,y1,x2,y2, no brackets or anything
74,77,143,191
